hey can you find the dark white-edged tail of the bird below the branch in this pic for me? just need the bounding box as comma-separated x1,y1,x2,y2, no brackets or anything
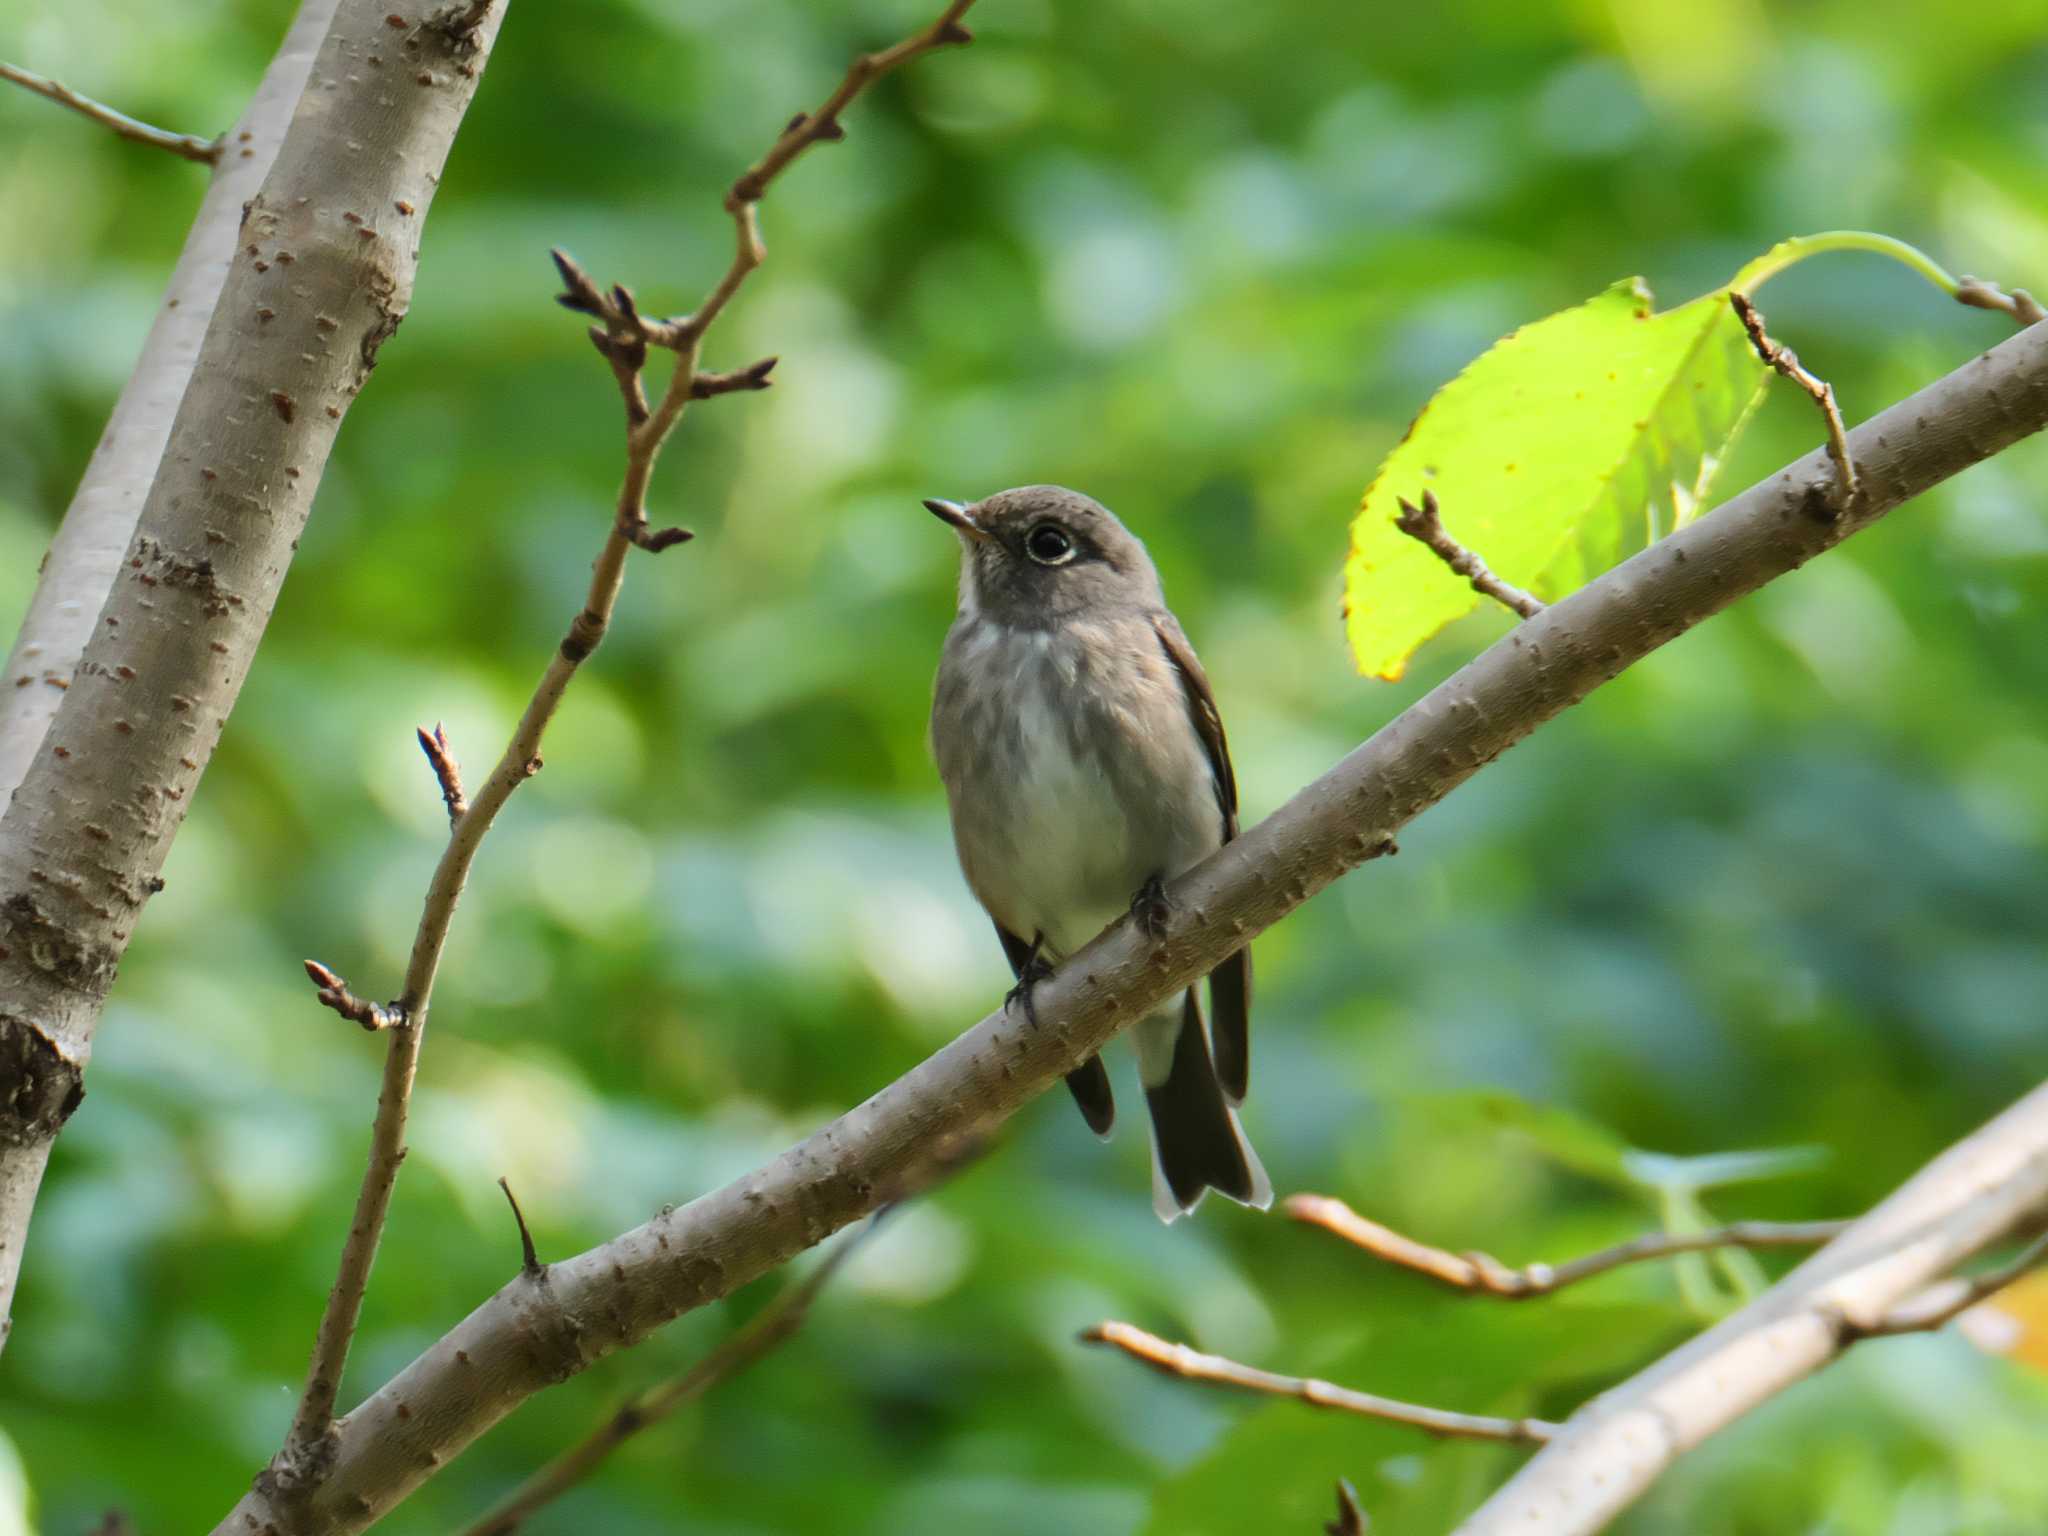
1135,987,1274,1221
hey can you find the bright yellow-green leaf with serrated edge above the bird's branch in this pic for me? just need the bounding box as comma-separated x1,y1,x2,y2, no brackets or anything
1343,279,1772,680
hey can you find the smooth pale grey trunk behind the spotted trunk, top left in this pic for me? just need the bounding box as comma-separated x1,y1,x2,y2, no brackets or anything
0,0,336,807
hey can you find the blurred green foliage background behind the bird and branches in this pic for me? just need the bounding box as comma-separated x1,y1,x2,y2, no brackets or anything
0,0,2048,1536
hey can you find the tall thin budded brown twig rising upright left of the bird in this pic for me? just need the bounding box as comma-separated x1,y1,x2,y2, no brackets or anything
266,0,973,1503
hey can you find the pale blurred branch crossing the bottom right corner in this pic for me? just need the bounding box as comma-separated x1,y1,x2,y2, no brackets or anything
1456,1081,2048,1536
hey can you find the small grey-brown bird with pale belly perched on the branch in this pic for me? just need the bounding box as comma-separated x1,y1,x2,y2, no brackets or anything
924,485,1272,1223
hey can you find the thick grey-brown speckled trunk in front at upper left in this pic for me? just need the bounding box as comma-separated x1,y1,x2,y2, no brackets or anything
0,0,506,1337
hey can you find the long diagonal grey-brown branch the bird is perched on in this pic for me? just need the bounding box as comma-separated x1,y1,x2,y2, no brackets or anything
207,290,2048,1536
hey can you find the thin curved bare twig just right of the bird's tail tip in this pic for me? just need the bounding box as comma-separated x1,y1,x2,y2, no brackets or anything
1282,1194,1849,1300
